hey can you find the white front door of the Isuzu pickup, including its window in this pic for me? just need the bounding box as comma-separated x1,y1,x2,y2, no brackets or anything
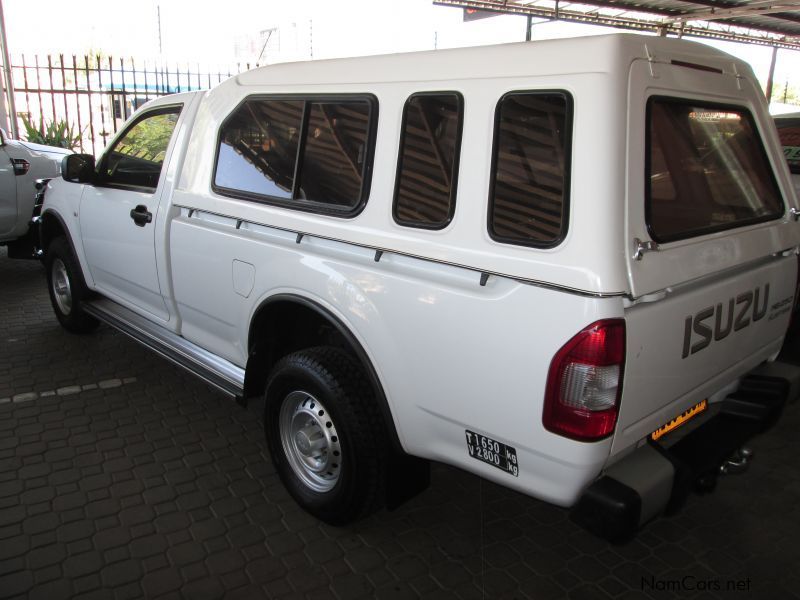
80,105,181,321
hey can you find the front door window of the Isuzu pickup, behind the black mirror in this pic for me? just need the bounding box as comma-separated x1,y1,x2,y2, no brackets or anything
99,106,181,189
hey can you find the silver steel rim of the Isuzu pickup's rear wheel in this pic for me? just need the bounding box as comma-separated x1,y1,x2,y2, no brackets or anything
278,391,342,492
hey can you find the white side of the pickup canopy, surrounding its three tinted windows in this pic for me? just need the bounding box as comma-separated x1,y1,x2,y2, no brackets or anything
175,36,648,293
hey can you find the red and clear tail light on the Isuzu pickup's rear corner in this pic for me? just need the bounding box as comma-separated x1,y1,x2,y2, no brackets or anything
542,319,625,441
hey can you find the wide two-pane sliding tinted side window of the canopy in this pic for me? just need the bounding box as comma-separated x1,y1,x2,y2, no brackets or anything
214,98,373,214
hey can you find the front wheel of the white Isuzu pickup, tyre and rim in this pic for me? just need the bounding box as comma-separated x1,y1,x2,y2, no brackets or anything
44,237,98,333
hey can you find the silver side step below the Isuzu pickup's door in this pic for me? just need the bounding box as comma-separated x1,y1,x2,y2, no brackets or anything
82,298,244,400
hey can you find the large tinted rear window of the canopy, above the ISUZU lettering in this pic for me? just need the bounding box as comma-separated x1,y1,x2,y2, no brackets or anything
646,98,783,242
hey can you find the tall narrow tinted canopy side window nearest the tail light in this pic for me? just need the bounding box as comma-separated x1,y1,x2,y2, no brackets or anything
489,92,572,247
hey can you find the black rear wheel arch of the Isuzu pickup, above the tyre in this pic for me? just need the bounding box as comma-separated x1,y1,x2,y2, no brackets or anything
244,293,405,453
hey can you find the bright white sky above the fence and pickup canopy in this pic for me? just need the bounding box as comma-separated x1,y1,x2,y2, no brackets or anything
2,0,800,105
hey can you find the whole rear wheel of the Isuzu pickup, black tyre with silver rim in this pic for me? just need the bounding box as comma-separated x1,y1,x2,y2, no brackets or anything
264,347,388,525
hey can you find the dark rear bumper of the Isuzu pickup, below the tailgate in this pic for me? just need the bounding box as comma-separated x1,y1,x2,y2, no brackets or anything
570,363,800,542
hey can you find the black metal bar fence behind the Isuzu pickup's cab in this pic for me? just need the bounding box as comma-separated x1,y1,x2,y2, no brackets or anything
6,54,258,155
